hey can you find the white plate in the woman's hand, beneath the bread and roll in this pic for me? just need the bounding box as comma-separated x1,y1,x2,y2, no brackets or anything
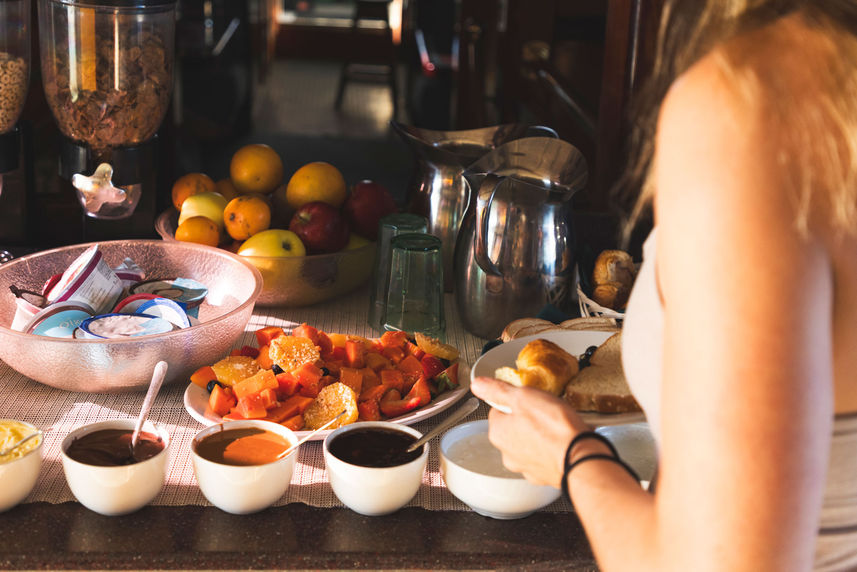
470,330,645,426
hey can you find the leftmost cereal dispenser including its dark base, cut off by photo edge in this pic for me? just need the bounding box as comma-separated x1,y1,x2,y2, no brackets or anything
0,0,30,241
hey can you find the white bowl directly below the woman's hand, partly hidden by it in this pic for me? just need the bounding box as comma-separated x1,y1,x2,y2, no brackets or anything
440,420,560,519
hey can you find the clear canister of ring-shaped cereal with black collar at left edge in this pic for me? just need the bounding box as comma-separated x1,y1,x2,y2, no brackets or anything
0,0,30,179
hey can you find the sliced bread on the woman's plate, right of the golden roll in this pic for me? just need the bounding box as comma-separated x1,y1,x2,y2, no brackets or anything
563,332,641,413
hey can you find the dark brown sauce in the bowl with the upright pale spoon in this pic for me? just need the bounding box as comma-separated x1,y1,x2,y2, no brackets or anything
65,429,165,467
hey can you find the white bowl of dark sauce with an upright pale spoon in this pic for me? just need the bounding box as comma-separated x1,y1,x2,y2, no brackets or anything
61,419,170,516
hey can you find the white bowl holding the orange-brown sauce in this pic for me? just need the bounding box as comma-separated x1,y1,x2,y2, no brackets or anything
191,419,298,514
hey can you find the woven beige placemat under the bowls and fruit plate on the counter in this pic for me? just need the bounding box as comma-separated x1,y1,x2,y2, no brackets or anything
0,292,571,512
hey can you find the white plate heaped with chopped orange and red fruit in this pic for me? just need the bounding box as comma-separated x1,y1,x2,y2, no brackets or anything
184,324,470,440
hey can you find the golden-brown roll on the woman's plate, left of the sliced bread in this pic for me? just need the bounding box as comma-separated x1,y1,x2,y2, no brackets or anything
494,339,578,395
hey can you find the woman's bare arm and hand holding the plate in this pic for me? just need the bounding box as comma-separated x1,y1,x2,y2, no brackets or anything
473,34,832,571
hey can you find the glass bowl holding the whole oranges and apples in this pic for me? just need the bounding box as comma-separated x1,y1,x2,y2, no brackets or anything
155,208,375,308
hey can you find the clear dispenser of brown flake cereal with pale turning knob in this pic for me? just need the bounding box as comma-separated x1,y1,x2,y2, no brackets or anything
39,0,176,229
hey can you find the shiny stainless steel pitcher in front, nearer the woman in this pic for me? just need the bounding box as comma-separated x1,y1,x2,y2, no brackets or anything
454,137,587,338
